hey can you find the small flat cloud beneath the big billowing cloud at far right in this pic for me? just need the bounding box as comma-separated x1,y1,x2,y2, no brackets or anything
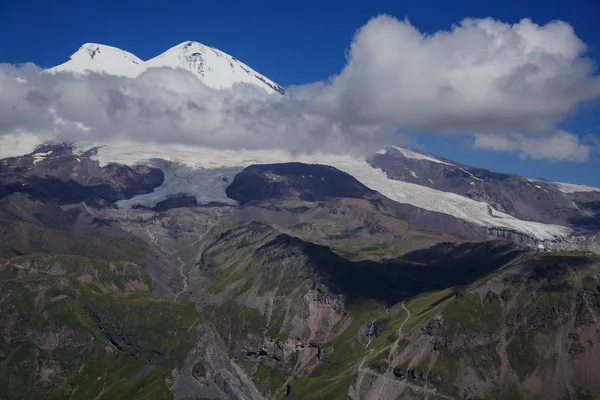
473,131,591,162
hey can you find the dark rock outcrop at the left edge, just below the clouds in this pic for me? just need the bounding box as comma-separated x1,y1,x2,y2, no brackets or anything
0,145,164,206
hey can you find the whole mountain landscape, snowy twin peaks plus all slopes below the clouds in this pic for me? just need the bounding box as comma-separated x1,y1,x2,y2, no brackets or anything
0,42,600,400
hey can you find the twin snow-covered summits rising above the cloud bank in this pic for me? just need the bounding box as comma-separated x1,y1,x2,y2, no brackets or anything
48,41,284,94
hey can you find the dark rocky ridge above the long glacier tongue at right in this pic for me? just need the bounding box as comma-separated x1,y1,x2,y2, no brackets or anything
370,148,600,229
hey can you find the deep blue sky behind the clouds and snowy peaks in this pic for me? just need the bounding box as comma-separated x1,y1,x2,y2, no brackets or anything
0,0,600,186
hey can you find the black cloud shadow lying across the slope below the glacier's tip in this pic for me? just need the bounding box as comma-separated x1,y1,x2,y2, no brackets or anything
273,235,522,306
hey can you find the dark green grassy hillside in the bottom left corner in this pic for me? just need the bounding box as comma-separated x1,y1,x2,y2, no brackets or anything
0,255,201,399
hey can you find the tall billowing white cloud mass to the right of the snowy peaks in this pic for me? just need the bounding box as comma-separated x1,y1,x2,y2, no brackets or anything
320,16,600,134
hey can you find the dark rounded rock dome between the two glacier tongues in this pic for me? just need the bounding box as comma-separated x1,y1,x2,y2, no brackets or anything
227,163,376,204
